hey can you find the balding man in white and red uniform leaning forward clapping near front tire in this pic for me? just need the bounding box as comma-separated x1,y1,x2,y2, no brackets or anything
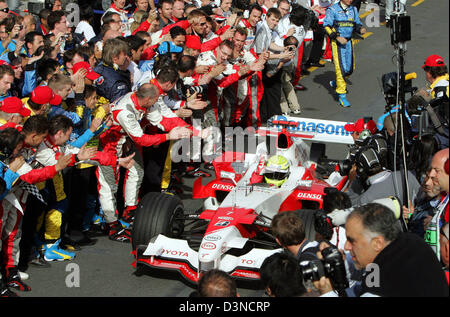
97,84,192,242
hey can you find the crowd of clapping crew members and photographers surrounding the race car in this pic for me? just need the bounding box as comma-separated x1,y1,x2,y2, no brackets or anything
0,0,449,296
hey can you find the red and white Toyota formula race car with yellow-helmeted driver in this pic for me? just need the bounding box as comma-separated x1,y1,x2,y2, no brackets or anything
132,116,351,283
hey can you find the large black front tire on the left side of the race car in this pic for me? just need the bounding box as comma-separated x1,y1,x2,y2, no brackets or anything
132,192,184,250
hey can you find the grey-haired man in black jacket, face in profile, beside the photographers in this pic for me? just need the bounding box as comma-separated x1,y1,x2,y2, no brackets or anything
314,203,449,297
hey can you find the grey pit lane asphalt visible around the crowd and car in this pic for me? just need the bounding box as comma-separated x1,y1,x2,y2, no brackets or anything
18,0,449,297
